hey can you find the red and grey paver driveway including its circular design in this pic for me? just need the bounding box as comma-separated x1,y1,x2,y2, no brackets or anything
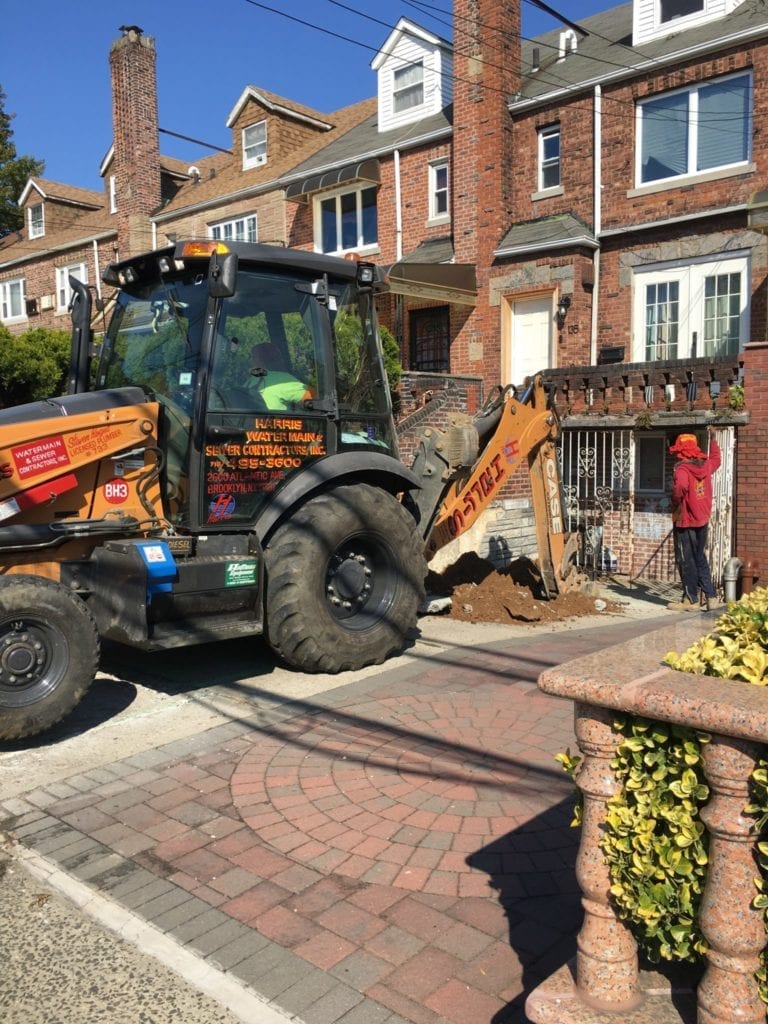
0,622,654,1024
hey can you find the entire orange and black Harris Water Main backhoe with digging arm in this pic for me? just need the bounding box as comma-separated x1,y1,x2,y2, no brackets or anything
0,240,566,740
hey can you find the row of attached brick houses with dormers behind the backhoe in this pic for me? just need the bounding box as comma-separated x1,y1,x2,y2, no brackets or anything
0,0,768,593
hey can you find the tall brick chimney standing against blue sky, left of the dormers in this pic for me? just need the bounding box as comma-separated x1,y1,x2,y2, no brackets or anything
110,25,161,259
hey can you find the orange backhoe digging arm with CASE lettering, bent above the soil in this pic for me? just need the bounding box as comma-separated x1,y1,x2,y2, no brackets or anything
412,376,575,597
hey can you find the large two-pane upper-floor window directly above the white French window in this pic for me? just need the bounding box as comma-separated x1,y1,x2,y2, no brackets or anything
637,73,752,185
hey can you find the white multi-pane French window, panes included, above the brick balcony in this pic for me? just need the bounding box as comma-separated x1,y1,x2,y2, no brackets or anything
632,253,751,362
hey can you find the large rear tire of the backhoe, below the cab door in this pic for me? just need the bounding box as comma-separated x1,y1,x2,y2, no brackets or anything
266,483,426,672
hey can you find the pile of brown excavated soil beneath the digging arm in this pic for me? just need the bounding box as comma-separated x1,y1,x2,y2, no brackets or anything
427,554,623,625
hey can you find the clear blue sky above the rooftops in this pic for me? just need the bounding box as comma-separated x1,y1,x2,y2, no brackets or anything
0,0,614,188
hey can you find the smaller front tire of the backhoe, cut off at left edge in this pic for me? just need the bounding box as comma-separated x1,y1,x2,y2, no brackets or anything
0,575,99,739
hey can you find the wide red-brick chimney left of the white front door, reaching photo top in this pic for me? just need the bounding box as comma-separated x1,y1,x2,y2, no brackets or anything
451,0,520,380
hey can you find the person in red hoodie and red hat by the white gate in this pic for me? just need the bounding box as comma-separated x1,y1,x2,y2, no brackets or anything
667,430,724,611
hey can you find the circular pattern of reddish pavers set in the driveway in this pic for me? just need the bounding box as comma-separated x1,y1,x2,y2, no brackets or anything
230,691,572,895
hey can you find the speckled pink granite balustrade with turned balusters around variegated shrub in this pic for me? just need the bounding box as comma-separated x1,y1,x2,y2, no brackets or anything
525,615,768,1024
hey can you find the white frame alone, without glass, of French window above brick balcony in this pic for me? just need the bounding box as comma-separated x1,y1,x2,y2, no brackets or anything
631,250,752,362
